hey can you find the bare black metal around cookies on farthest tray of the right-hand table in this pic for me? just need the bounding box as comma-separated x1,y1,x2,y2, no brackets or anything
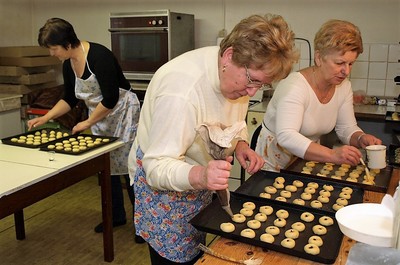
281,159,392,193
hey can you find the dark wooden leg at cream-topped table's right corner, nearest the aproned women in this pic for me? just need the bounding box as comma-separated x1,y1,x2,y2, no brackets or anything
99,154,114,262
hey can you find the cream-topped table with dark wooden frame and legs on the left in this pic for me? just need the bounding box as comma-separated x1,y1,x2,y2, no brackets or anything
0,141,123,262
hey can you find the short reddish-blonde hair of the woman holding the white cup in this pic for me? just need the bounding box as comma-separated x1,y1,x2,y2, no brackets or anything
314,19,363,56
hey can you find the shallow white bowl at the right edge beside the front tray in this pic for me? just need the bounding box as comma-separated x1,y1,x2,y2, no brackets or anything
336,203,393,247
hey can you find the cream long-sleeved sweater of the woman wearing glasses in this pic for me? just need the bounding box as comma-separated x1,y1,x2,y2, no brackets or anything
129,46,249,191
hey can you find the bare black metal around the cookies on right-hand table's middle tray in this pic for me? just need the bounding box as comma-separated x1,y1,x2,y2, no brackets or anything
235,171,364,213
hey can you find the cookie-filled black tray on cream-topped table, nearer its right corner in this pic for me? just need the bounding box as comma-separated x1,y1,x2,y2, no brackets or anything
40,134,118,155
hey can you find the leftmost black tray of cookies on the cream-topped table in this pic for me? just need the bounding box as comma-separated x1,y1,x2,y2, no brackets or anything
1,128,70,148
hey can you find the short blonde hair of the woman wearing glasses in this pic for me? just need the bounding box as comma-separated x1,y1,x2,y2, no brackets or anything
220,14,299,81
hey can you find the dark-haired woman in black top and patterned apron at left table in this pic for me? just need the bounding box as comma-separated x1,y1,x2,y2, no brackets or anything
28,18,140,239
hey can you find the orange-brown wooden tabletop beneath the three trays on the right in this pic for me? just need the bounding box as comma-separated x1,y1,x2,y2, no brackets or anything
195,168,400,265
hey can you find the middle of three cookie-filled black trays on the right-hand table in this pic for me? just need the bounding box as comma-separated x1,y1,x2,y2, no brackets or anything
236,171,364,213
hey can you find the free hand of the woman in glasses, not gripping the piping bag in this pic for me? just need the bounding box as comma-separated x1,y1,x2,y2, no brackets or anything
235,141,265,174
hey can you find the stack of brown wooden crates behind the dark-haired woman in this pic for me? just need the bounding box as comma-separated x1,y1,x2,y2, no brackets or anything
0,46,62,131
